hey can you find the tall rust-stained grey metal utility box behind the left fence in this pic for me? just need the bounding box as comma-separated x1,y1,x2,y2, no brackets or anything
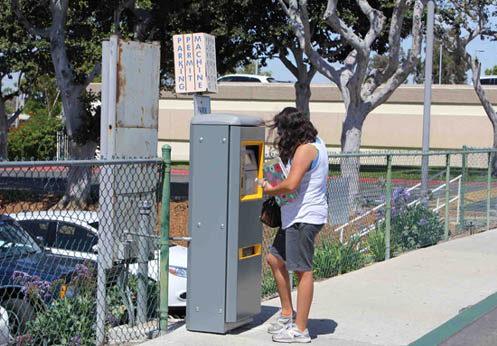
99,35,160,268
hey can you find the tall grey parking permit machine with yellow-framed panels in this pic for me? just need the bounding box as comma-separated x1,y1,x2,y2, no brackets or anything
186,114,265,333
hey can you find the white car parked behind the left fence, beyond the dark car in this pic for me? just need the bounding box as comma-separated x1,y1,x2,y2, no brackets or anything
9,210,188,308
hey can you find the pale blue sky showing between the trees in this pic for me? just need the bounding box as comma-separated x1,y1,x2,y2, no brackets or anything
262,38,497,83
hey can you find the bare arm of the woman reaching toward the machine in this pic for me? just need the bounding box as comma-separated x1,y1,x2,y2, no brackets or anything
264,144,318,196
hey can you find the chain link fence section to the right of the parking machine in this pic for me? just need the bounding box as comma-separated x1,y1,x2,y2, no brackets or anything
262,149,497,297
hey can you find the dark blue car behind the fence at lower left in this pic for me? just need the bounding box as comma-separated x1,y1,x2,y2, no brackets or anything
0,214,96,339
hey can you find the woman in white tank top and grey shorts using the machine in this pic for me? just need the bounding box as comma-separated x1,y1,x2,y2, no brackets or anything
263,107,328,342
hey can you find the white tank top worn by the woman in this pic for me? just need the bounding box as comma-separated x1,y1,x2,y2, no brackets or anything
281,137,328,229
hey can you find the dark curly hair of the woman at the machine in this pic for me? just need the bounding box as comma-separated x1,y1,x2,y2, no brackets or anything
268,107,318,165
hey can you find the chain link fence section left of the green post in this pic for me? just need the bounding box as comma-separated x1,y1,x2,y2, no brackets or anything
0,159,166,345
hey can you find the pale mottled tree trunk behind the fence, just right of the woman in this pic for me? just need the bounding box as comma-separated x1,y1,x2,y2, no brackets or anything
340,109,366,215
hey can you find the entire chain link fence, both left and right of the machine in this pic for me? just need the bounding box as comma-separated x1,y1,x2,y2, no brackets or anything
0,150,497,345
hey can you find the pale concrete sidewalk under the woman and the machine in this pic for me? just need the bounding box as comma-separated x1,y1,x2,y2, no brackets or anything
142,230,497,346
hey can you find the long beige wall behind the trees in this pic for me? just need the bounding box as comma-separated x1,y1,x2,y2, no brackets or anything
159,83,497,160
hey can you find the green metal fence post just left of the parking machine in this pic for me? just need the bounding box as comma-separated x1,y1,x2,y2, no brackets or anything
159,144,171,332
